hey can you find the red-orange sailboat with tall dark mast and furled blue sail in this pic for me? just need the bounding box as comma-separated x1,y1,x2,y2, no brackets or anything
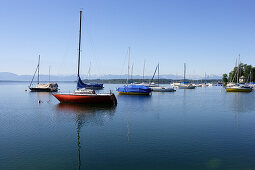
53,11,117,105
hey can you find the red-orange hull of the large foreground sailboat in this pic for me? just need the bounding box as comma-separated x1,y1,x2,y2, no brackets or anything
53,93,117,104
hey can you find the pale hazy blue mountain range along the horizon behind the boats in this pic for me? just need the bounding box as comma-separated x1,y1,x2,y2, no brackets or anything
0,72,222,81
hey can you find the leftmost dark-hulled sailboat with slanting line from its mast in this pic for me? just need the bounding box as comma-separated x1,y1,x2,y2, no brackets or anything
28,55,58,92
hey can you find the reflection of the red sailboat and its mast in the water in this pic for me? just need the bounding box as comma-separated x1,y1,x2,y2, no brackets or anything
56,103,116,170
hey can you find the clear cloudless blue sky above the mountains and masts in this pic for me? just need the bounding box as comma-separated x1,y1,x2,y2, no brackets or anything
0,0,255,75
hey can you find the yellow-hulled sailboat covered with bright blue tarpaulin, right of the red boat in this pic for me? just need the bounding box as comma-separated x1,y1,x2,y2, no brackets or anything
116,47,151,95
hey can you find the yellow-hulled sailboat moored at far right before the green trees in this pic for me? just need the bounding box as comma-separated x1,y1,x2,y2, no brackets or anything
226,55,252,92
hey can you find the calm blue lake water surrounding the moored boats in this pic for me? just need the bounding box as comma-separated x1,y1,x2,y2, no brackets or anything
0,82,255,170
